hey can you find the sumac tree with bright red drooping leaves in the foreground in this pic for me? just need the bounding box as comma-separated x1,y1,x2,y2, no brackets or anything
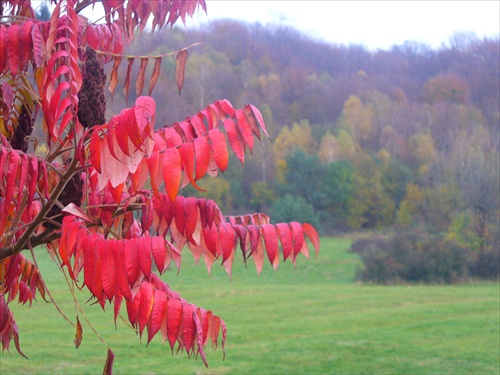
0,0,319,373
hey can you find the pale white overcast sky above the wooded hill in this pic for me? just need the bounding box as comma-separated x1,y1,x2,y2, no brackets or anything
186,0,500,50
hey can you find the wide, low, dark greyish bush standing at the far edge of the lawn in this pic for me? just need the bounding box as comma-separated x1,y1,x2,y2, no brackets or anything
351,232,472,283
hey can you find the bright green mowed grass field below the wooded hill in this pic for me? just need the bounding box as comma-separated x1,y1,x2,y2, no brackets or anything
0,238,500,374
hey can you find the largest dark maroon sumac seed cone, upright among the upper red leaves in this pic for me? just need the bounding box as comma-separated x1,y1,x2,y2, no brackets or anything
78,47,106,128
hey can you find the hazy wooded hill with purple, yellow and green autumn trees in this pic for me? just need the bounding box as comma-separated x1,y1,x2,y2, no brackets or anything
109,20,500,253
